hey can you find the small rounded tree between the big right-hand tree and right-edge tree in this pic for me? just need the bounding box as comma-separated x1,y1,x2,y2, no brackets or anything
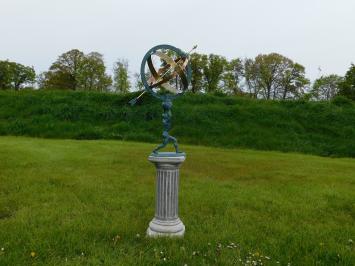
311,74,343,100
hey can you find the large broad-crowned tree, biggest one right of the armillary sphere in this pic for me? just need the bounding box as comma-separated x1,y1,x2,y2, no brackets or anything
244,53,309,99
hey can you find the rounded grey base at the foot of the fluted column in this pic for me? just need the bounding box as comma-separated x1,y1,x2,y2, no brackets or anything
147,218,185,237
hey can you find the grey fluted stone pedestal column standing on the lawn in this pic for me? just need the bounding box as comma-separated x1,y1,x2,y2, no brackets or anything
147,152,186,237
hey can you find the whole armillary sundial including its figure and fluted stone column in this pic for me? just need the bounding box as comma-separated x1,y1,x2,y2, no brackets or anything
130,44,196,237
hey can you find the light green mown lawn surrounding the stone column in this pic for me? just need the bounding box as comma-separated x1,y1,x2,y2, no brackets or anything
0,137,355,265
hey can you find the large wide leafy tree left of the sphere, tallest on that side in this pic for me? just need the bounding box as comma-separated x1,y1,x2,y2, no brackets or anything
40,49,112,91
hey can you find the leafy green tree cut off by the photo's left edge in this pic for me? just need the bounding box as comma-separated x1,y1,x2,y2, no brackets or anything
0,61,36,90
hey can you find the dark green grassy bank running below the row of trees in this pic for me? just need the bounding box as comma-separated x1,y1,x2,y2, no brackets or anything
0,91,355,157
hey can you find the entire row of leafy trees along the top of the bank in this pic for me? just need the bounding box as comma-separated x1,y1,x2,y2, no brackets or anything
0,49,355,100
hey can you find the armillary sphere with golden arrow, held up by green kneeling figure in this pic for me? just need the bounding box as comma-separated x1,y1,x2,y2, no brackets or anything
130,44,197,153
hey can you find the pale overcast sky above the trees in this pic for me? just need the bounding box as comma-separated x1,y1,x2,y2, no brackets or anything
0,0,355,80
